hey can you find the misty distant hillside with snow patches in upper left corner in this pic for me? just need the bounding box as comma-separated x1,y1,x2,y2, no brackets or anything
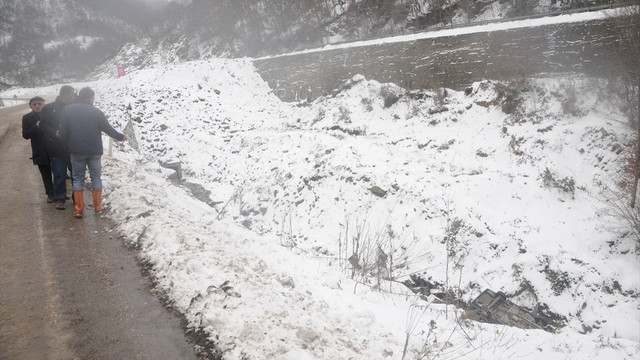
0,0,153,89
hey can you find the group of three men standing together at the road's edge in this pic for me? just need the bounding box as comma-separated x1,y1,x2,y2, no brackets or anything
22,85,127,218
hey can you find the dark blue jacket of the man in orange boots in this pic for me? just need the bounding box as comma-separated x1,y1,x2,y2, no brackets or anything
60,102,124,155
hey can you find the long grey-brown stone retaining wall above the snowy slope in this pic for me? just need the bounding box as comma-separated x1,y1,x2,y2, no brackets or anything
254,19,625,101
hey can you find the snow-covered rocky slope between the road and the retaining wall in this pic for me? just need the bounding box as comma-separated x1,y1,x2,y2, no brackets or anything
2,59,640,359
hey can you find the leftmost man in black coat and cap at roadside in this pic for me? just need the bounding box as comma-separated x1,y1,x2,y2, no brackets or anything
22,96,53,203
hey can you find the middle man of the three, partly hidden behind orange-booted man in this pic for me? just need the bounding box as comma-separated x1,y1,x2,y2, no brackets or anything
41,85,76,210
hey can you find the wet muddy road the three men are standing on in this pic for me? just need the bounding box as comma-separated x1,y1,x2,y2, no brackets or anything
0,105,196,360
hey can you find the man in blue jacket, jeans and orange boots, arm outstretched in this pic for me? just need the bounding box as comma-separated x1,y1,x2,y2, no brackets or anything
59,87,127,218
